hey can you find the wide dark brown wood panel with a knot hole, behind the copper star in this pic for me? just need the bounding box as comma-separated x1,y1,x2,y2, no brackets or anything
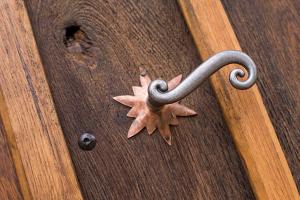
25,0,254,199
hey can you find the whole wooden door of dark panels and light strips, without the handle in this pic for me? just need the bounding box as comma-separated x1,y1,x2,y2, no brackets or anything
0,0,300,199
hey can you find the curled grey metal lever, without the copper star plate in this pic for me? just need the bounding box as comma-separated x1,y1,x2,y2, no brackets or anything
148,51,257,108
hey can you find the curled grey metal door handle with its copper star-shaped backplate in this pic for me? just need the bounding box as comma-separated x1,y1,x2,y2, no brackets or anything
114,51,257,144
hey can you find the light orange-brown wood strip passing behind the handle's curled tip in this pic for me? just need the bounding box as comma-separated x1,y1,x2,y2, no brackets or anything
179,0,298,200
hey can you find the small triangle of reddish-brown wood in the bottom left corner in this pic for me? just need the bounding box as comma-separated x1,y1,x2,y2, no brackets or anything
0,110,23,200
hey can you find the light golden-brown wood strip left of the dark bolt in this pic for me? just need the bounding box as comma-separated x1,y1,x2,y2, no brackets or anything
0,0,82,199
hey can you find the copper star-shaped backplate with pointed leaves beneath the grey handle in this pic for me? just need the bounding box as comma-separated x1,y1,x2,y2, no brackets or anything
114,71,197,145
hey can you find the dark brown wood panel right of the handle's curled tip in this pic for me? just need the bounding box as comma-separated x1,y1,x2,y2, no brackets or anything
223,0,300,190
